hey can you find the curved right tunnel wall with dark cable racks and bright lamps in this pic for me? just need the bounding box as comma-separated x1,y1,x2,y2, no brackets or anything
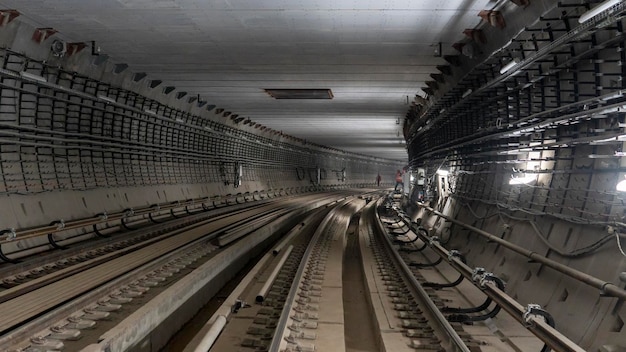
400,1,626,351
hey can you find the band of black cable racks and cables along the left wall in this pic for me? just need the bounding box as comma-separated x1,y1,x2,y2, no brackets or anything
0,50,393,193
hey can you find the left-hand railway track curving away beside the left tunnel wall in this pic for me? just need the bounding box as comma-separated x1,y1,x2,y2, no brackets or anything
0,193,354,351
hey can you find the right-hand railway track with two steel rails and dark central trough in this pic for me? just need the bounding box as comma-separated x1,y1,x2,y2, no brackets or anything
193,195,476,351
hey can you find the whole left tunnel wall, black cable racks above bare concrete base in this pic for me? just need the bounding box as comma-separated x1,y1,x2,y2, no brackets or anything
0,20,402,242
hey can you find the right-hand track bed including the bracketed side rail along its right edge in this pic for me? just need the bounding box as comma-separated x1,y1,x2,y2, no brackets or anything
184,194,582,352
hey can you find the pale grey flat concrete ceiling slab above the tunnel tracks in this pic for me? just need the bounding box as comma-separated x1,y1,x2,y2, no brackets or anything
0,0,495,160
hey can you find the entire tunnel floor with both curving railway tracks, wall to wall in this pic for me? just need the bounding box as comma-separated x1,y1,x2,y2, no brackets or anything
0,193,582,352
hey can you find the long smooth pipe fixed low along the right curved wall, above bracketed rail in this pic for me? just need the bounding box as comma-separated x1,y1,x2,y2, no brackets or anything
417,204,626,299
